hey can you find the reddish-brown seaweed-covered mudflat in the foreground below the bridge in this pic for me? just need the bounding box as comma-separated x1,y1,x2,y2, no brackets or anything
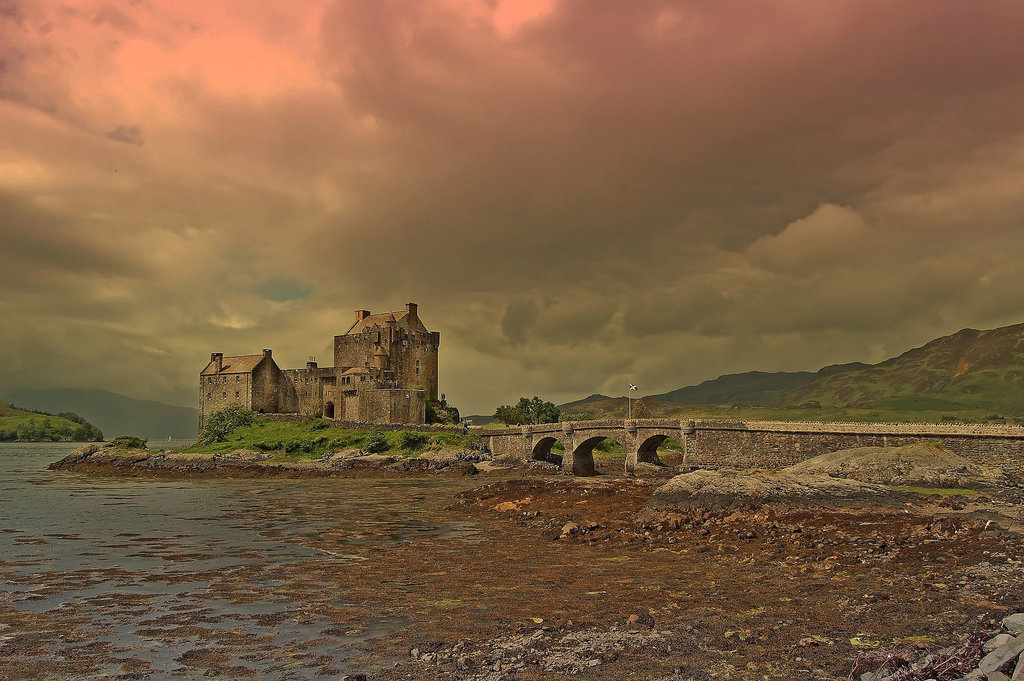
25,444,1024,680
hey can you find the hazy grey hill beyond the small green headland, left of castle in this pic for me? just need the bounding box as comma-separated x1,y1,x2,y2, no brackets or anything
4,389,199,439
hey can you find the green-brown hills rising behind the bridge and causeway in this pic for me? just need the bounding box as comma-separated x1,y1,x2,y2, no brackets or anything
548,324,1024,422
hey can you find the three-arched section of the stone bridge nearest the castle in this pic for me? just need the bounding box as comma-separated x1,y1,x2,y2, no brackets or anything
476,419,693,475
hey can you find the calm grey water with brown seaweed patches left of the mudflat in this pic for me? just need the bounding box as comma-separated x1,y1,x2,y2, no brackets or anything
0,442,476,679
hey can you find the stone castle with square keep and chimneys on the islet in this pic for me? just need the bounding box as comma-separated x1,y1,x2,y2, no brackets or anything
199,303,440,431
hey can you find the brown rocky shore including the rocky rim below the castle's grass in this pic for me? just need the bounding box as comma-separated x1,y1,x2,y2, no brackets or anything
29,438,1024,681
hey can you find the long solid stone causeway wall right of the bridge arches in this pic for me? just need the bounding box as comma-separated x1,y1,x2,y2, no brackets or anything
686,420,1024,474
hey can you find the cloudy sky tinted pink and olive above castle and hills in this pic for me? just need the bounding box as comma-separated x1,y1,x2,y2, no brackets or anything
0,0,1024,414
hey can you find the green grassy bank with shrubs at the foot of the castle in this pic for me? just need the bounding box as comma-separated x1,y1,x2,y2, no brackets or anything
181,419,479,461
